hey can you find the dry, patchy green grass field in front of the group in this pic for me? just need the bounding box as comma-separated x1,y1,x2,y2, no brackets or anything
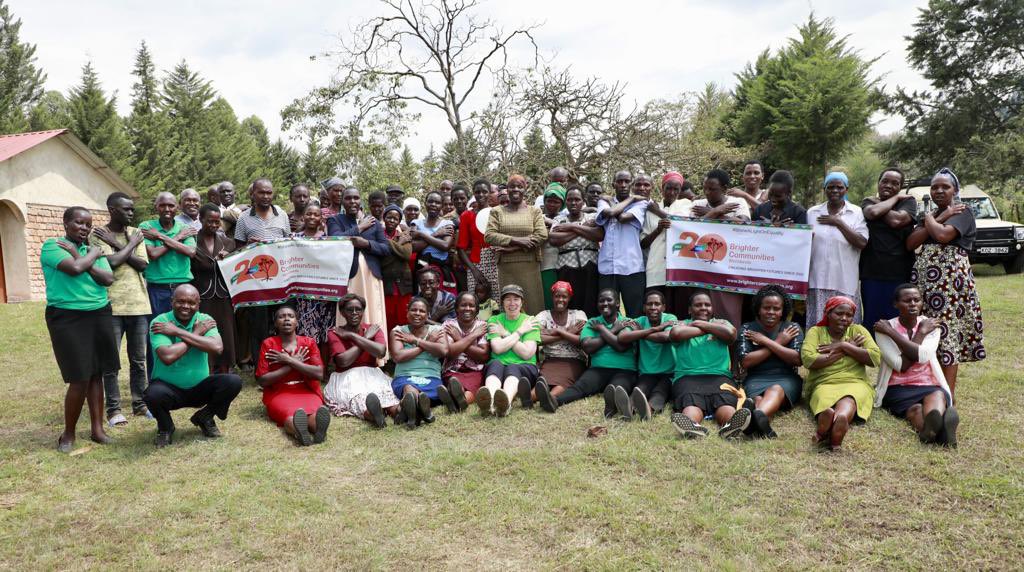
0,268,1024,570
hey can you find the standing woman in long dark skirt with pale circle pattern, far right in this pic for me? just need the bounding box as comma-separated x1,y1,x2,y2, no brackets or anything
906,168,985,396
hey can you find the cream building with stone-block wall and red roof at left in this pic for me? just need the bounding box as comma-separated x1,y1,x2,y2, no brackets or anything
0,129,138,303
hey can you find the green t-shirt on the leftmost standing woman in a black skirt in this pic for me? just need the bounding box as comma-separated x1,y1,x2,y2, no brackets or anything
39,238,111,310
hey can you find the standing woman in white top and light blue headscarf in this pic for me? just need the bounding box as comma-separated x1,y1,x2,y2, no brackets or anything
807,171,867,324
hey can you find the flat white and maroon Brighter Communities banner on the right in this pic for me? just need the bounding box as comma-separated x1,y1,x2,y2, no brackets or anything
665,217,813,299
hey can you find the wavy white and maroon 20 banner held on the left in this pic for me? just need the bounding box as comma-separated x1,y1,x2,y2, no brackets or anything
218,236,353,308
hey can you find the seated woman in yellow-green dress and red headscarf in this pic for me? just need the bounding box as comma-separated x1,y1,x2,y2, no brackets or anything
800,296,881,451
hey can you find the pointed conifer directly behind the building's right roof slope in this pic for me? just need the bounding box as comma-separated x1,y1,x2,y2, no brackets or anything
68,62,131,178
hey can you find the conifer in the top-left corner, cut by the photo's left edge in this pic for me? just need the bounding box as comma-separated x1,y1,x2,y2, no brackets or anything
0,0,46,133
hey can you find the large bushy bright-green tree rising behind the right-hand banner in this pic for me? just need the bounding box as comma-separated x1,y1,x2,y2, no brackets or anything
729,13,879,203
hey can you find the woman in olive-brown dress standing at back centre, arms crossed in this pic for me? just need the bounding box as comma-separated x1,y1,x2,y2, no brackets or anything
484,175,548,313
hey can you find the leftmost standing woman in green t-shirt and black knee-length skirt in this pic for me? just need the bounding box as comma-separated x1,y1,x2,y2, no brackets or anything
40,207,121,453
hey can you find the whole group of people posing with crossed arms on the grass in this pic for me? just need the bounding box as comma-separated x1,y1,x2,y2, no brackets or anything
41,162,984,451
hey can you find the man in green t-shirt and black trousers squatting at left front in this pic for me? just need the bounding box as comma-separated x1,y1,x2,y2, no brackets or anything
142,284,242,447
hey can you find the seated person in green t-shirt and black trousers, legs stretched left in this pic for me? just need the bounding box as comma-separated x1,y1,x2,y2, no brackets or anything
538,289,637,420
